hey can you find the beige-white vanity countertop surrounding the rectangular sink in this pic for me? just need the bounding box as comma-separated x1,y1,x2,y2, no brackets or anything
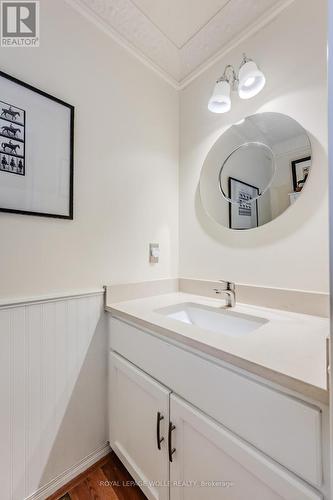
106,292,329,402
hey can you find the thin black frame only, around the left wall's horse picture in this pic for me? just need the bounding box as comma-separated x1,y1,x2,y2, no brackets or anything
0,71,75,220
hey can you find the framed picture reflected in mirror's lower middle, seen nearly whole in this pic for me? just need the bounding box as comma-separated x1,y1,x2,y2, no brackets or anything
229,177,260,229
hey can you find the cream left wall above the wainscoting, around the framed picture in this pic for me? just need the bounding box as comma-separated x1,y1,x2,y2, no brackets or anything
0,0,179,298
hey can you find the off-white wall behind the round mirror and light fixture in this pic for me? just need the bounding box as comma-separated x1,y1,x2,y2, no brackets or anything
179,0,328,291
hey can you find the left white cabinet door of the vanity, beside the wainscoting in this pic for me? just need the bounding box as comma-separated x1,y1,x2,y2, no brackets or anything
109,352,170,500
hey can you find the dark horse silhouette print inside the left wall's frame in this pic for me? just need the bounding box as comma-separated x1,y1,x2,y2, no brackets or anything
0,101,25,175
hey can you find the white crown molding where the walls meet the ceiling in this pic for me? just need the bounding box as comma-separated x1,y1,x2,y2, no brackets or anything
65,0,295,90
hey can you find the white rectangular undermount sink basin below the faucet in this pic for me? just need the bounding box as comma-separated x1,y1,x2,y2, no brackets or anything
155,302,268,337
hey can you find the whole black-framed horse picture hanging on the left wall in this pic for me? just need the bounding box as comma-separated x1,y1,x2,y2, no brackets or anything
0,71,74,219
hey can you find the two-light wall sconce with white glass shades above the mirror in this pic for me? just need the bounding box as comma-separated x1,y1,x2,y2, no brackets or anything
208,54,266,113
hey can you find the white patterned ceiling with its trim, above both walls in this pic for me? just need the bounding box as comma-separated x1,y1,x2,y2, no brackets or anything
67,0,293,88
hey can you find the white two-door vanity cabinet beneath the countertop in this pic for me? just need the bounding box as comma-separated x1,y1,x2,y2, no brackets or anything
109,318,329,500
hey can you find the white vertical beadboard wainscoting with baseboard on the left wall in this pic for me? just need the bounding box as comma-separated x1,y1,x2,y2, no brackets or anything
0,291,109,500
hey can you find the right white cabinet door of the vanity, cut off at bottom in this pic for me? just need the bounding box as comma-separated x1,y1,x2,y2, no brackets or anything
168,394,322,500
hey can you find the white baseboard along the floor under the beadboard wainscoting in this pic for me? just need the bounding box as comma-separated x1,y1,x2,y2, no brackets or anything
25,443,111,500
